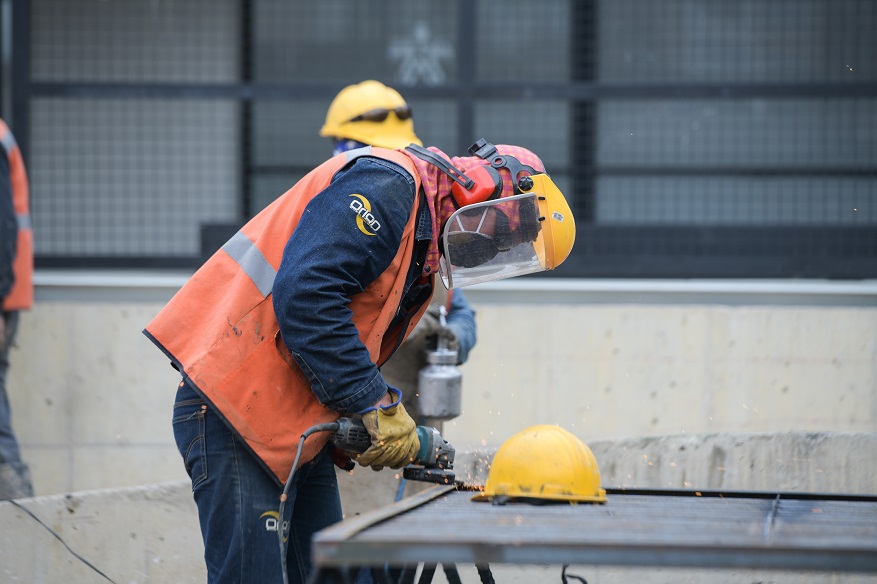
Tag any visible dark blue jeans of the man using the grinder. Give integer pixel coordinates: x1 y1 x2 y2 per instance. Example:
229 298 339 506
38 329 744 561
173 382 341 584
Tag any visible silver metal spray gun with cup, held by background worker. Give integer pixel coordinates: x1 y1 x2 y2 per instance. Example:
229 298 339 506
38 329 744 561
418 306 463 420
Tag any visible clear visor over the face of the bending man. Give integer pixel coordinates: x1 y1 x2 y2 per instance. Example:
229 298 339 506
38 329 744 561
439 192 550 289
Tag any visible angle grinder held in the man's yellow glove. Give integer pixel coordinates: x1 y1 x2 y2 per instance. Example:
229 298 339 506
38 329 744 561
329 418 455 484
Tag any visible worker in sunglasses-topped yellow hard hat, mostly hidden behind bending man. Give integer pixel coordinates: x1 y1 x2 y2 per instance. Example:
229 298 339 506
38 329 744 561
320 79 477 426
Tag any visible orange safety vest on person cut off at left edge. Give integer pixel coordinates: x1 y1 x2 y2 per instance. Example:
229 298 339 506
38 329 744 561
0 120 33 311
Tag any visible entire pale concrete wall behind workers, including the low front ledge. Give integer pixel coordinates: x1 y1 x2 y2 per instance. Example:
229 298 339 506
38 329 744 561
0 273 877 584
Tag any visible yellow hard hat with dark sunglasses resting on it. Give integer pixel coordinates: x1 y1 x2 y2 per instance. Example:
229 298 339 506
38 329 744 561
320 80 423 149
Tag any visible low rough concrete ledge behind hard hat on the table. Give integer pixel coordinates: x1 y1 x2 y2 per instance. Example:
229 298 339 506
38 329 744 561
455 432 877 495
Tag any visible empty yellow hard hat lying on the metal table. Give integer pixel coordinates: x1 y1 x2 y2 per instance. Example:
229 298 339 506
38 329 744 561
472 424 606 503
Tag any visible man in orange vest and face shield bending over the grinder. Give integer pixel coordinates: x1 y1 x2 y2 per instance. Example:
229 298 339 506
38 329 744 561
144 129 575 584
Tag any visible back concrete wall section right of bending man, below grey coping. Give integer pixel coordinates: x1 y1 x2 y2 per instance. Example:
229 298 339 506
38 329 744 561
446 304 877 452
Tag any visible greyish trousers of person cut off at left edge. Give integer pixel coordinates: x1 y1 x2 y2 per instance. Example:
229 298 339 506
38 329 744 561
0 310 33 500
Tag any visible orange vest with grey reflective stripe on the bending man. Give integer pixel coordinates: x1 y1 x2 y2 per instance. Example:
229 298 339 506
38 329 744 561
144 148 432 484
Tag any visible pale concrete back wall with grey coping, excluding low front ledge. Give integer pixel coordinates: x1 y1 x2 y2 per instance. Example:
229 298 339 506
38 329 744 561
3 272 877 495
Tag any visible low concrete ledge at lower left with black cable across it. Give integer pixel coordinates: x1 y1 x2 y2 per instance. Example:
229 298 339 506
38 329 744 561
0 480 200 584
